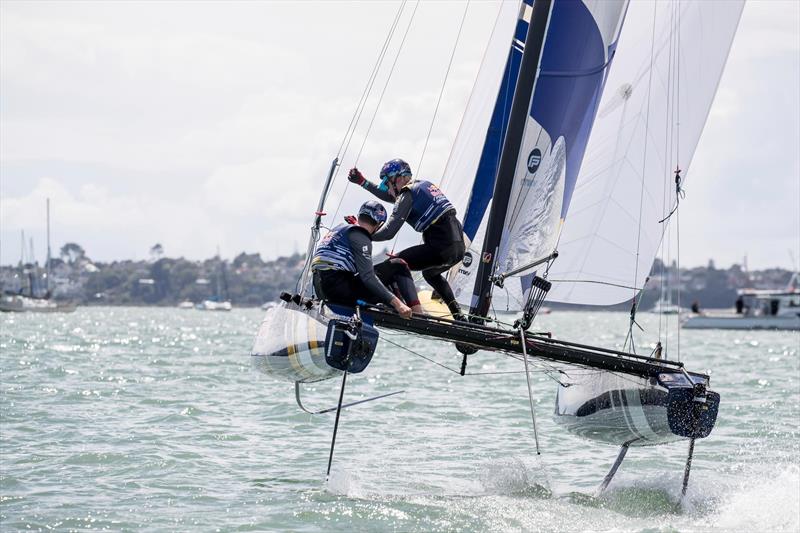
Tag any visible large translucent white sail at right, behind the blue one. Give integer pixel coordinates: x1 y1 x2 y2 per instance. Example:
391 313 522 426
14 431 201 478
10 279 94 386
548 0 744 305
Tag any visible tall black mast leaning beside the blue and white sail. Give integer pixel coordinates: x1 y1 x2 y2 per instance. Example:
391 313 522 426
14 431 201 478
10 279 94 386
470 0 551 316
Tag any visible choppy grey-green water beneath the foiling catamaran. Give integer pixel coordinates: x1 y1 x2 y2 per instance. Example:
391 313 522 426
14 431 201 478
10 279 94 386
0 308 800 531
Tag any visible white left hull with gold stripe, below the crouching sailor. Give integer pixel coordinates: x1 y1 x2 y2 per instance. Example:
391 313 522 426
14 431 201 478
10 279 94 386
250 304 341 383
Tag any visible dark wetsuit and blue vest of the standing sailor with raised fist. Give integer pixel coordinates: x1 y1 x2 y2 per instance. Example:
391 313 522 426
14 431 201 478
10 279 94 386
363 181 466 305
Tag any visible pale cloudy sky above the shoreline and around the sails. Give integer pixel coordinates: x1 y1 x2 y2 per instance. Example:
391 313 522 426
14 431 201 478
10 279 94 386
0 0 800 268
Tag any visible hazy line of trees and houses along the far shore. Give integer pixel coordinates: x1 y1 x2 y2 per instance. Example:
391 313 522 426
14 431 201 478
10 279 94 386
0 243 792 310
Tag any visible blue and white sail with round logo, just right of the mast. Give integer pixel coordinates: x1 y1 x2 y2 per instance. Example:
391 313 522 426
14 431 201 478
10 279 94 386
493 0 628 308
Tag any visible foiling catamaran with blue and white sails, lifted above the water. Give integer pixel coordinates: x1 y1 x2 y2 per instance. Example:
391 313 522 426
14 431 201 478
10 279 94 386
251 0 743 493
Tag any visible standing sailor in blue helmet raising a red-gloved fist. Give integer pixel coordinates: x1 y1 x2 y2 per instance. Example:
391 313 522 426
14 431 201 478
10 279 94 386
347 159 465 320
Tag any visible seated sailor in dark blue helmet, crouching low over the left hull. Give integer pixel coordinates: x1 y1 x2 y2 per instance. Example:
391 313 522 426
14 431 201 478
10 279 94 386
311 201 419 318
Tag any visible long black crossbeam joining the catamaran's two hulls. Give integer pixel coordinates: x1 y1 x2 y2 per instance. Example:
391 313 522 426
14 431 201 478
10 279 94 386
361 306 696 379
